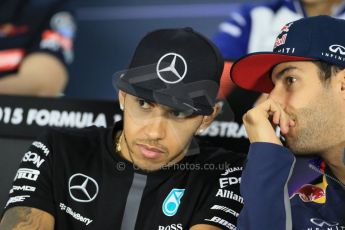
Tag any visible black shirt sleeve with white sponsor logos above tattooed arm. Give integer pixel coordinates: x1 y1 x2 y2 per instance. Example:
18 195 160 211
3 130 55 216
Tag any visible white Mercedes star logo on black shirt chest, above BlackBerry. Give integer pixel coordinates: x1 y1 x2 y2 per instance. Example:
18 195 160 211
68 173 98 203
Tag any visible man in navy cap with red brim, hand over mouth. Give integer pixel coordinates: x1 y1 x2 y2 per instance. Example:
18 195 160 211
231 16 345 230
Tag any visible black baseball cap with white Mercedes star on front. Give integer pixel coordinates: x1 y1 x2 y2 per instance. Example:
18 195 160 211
115 28 224 115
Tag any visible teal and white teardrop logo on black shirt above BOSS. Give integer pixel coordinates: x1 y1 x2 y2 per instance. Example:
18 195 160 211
162 188 185 216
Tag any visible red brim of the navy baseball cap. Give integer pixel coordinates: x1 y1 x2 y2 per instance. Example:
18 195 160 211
230 52 317 93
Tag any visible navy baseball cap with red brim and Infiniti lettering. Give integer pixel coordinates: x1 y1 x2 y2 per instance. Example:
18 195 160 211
230 15 345 93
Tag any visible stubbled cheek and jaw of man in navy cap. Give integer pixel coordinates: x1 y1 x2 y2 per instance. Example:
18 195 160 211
286 90 344 155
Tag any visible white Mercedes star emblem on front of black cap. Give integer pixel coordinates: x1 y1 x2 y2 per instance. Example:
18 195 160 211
156 53 187 84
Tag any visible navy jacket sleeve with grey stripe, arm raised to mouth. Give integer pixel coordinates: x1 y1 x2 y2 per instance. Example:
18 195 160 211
237 142 295 230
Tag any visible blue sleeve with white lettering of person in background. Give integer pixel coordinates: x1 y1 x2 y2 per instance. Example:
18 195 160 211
212 5 251 61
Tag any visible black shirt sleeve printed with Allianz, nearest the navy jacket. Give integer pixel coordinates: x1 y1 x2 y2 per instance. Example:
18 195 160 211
191 156 243 230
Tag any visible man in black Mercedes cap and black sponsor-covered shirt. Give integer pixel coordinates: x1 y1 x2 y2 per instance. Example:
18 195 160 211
0 28 243 230
